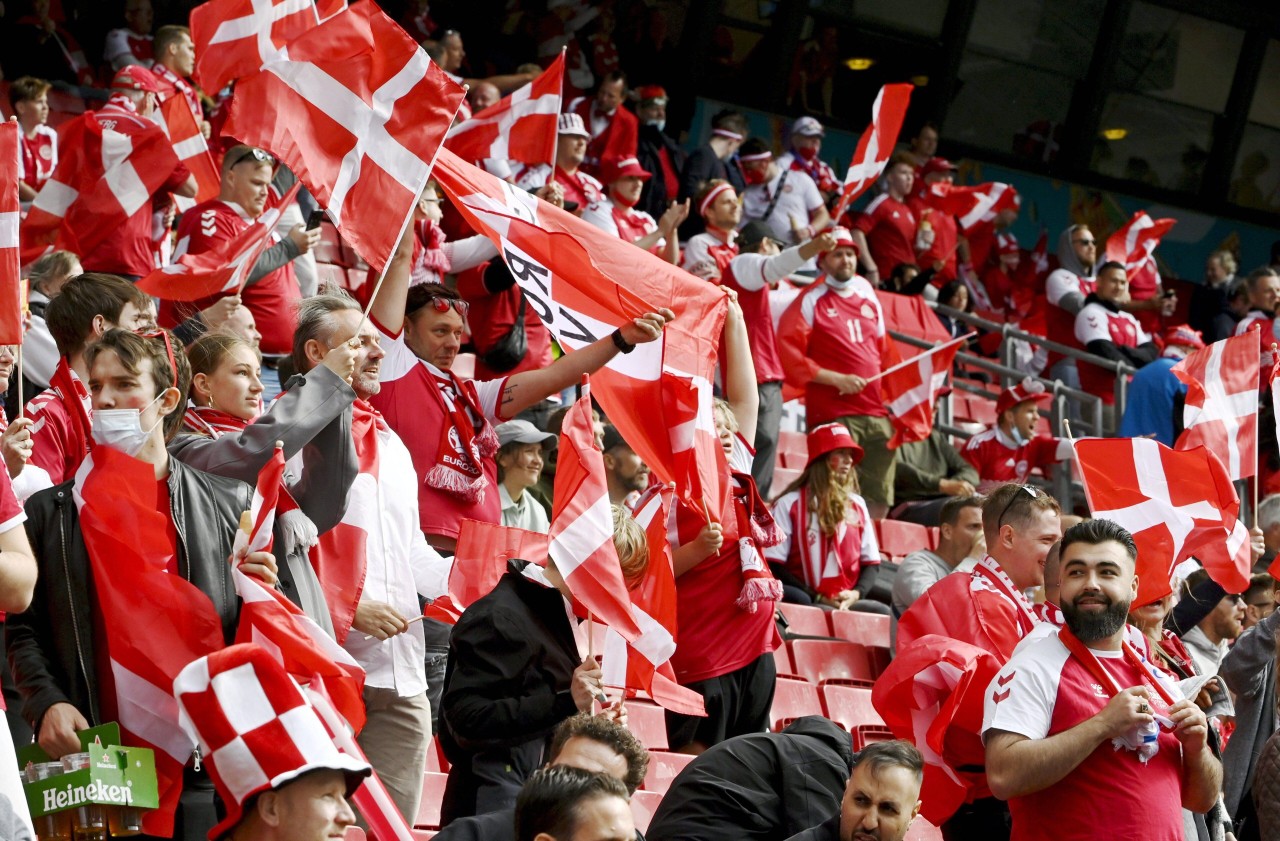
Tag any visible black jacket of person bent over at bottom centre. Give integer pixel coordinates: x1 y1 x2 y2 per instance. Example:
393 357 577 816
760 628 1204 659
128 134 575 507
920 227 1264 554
645 716 854 841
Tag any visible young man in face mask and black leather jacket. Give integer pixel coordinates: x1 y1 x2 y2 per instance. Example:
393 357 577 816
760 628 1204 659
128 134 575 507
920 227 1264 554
6 329 276 837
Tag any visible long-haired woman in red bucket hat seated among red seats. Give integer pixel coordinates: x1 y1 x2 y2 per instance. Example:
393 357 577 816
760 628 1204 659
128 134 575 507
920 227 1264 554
764 422 890 616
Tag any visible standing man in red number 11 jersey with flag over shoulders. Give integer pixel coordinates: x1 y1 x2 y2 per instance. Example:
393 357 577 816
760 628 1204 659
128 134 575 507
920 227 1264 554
778 228 896 520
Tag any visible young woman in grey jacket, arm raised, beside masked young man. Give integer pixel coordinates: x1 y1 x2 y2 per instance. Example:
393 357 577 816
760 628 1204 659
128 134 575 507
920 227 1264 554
169 330 356 629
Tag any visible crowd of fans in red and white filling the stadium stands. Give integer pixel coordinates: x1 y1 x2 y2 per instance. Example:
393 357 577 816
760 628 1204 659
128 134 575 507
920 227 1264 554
0 0 1280 841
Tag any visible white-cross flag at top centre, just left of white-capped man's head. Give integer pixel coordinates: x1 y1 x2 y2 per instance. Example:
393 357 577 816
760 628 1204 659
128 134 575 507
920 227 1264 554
444 51 564 166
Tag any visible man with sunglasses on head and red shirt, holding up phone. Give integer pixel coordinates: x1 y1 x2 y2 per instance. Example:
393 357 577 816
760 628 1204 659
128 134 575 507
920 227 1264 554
160 146 320 356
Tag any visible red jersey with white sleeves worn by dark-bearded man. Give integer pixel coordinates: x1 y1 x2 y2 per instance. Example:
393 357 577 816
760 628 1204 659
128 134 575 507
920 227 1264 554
982 634 1183 841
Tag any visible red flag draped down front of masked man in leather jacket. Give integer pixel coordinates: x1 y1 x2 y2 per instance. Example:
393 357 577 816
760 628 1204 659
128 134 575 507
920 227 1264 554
73 445 224 837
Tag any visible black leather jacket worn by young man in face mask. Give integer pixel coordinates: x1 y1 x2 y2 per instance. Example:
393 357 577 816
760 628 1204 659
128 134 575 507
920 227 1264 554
5 458 252 732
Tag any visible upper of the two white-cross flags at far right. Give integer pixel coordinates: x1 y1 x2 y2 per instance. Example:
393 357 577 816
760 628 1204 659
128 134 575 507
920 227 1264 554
1172 332 1258 478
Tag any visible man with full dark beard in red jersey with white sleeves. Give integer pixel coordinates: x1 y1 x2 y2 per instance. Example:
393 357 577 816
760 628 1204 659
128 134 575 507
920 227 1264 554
983 520 1222 841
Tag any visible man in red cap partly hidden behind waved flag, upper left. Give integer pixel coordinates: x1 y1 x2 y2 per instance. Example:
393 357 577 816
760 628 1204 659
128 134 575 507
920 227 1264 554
81 64 196 280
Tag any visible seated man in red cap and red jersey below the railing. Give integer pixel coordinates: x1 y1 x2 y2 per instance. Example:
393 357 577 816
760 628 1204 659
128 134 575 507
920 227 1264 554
960 378 1071 493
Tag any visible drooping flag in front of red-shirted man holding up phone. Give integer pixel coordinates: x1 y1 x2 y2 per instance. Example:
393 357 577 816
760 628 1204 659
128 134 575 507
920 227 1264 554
138 183 301 301
